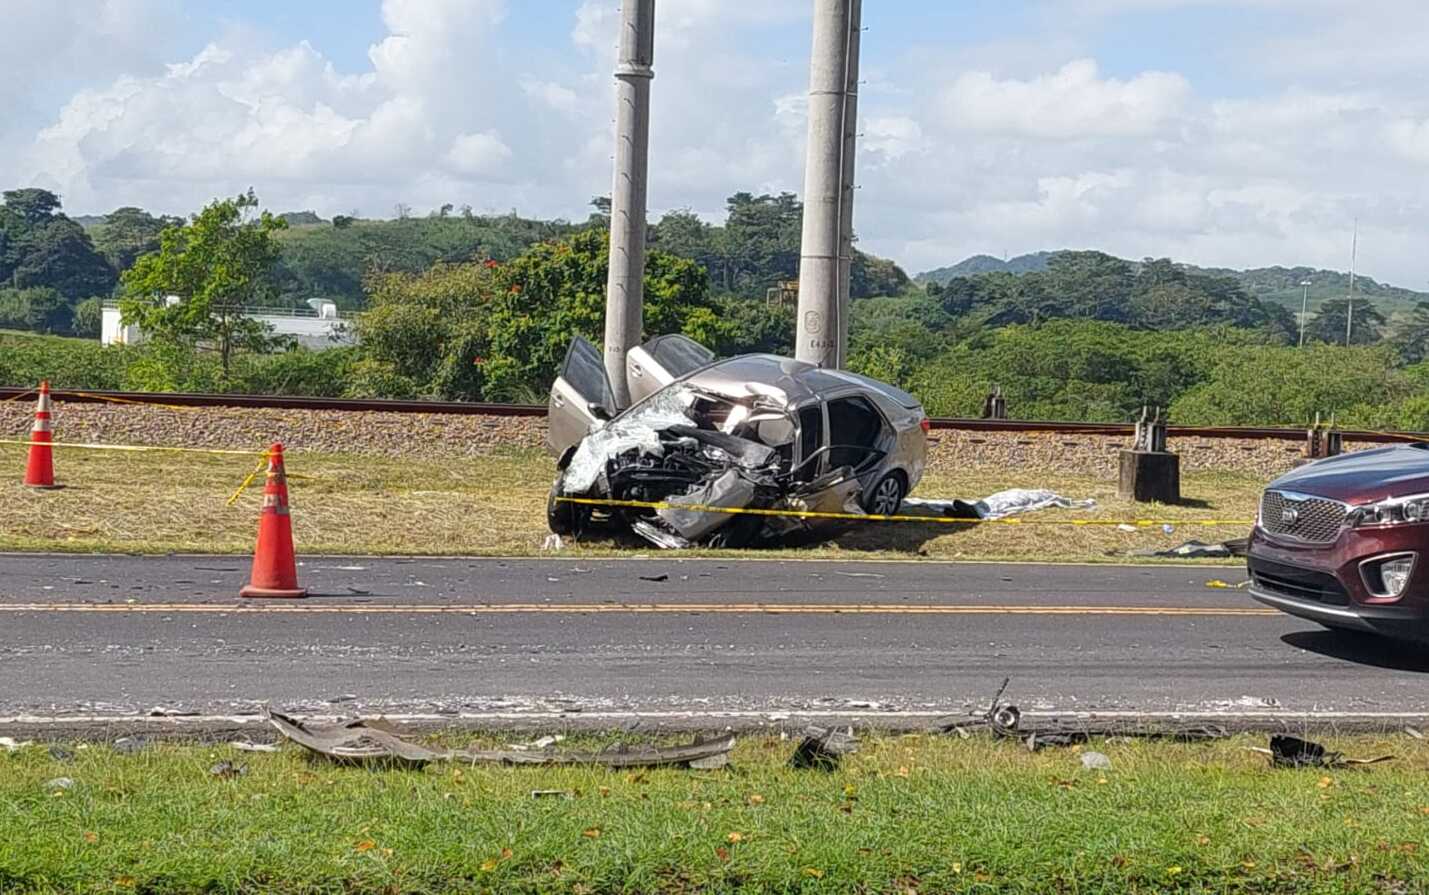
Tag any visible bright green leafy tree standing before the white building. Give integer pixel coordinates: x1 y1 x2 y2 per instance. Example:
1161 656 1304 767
120 190 287 380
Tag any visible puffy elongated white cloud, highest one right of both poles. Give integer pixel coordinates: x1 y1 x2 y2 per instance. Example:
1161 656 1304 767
942 59 1190 139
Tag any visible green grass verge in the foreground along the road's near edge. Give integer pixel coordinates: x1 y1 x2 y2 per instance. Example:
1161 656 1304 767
0 736 1429 894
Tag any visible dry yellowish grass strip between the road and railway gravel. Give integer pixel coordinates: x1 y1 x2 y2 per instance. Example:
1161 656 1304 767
0 446 1262 562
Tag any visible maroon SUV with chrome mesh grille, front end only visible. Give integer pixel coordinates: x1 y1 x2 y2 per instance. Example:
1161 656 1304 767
1248 445 1429 639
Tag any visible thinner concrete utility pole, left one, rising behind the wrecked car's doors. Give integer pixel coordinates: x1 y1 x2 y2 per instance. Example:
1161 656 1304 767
606 0 654 407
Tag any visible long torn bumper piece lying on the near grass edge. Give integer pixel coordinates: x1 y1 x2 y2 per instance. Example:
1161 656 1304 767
266 711 735 771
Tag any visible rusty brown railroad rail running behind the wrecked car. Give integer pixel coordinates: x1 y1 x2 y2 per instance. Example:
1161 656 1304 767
0 386 1429 445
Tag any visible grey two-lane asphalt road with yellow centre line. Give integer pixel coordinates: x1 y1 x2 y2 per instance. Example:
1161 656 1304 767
0 555 1429 728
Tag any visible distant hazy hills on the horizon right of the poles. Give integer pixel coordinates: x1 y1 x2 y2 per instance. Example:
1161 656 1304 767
916 252 1429 316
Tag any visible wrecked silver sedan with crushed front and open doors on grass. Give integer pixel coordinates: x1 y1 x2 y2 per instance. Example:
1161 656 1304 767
546 336 927 548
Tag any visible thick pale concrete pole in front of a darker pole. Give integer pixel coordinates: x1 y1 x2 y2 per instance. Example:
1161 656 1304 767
795 0 850 367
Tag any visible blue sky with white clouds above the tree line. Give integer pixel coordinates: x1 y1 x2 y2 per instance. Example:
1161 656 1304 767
0 0 1429 287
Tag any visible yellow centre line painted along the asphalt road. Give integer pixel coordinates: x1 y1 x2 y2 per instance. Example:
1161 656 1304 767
0 602 1280 616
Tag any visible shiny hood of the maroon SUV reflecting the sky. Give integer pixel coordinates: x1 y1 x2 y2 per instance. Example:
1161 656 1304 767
1270 443 1429 503
